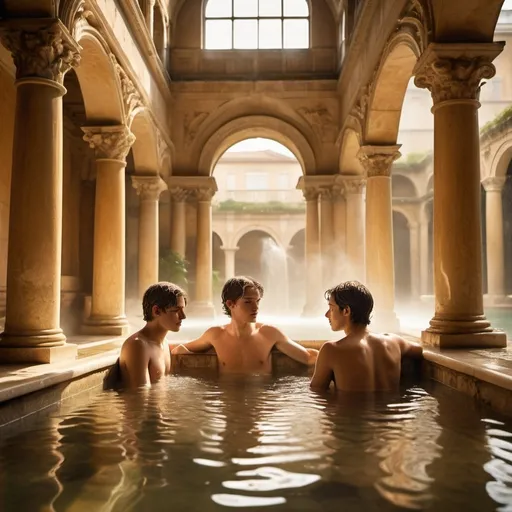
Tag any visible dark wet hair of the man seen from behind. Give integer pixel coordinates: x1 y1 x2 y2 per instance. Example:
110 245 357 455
325 281 373 325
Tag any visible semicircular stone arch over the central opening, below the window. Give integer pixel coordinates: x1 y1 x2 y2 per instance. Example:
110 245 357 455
198 115 316 176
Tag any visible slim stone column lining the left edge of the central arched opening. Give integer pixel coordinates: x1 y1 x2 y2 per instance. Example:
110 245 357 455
191 184 217 318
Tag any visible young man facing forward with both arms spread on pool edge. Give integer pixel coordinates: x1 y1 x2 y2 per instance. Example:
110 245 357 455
172 276 318 374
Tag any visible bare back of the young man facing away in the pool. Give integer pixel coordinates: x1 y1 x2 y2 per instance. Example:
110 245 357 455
311 333 414 391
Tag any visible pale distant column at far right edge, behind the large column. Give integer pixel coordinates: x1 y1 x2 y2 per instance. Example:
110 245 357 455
482 176 506 304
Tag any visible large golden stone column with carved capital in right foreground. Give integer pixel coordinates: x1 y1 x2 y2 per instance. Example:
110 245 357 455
414 43 506 347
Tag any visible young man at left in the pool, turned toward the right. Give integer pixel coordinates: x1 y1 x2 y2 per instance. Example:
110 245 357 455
119 282 187 389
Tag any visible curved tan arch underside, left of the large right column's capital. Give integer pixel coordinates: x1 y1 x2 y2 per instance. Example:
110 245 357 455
364 31 421 145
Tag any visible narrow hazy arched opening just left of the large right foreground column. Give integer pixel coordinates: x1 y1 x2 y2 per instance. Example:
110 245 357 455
393 211 412 303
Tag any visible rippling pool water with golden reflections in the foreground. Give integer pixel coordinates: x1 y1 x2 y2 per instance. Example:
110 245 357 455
0 376 512 512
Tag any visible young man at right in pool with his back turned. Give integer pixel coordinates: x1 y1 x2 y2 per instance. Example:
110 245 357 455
311 281 423 391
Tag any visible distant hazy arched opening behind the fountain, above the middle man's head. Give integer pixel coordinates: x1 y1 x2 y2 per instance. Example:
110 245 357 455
235 231 288 315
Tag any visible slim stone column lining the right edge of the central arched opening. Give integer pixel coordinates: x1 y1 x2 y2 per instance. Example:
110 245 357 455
302 187 323 316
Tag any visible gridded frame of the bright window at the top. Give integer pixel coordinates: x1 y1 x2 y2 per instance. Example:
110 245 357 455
202 0 311 52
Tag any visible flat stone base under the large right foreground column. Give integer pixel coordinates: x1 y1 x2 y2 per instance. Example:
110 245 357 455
421 329 507 348
